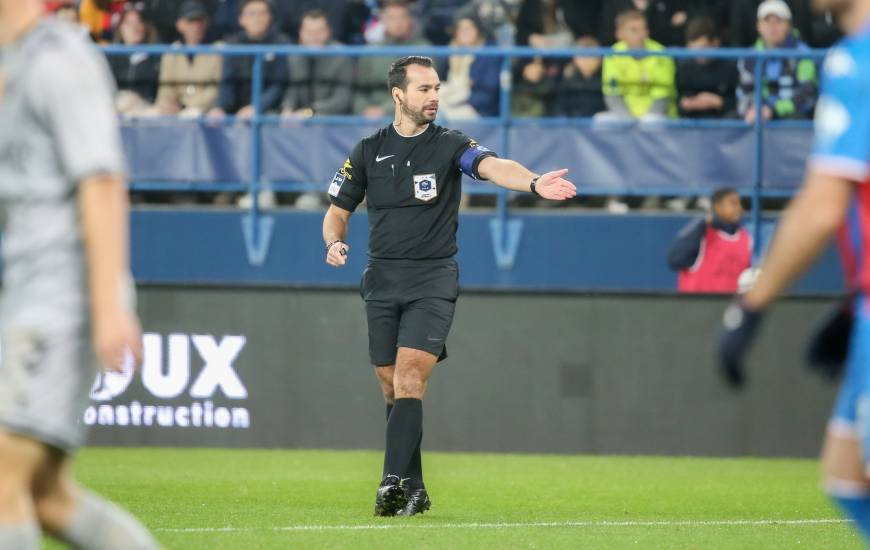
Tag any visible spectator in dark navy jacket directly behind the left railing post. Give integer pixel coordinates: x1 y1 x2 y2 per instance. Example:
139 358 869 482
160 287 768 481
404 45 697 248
208 0 289 118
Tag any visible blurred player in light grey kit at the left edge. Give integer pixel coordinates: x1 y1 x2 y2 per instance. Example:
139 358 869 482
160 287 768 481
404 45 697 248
0 0 157 550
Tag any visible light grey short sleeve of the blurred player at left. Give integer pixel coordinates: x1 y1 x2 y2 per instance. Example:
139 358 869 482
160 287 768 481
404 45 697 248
26 49 125 185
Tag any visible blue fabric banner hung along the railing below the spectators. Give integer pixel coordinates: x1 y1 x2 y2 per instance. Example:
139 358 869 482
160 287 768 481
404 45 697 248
123 121 812 196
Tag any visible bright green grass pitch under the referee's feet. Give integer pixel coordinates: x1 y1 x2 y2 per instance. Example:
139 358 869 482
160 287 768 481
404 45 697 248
49 448 862 550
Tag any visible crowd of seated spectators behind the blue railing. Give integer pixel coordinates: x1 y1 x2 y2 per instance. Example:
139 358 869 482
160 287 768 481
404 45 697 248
49 0 840 209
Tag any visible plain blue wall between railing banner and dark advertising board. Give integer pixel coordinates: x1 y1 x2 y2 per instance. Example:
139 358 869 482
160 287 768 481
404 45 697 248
131 208 843 294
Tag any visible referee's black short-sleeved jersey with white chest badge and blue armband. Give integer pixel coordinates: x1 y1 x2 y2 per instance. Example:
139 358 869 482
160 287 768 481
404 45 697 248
329 124 495 260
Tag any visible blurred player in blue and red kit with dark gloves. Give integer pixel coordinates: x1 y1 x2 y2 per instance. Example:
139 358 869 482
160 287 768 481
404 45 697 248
718 0 870 540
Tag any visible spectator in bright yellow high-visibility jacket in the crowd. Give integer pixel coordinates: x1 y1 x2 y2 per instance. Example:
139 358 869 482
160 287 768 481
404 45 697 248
601 10 677 118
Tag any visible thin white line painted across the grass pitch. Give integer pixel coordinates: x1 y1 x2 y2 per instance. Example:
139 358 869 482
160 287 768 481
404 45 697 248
154 519 849 533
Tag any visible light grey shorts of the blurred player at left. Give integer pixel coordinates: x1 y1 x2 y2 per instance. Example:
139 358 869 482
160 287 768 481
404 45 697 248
0 327 96 453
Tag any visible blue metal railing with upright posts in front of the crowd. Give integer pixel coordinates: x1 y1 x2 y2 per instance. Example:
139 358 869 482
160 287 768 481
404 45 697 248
103 44 827 256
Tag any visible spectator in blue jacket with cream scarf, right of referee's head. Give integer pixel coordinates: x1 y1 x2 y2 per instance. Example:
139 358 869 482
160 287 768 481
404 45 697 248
439 16 501 119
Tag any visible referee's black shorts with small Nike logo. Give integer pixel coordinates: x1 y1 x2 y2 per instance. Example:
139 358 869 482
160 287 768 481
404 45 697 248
360 258 459 366
